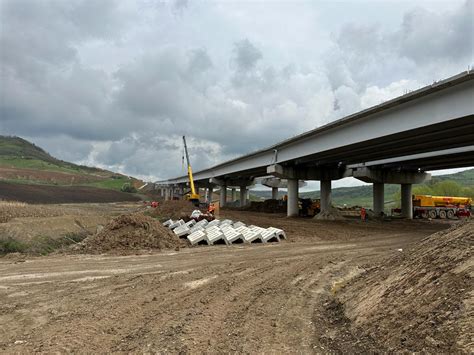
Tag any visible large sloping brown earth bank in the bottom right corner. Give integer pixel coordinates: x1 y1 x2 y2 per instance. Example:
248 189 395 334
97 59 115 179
339 221 474 353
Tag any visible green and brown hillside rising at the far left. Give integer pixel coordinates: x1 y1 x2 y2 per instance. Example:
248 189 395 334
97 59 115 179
0 136 142 191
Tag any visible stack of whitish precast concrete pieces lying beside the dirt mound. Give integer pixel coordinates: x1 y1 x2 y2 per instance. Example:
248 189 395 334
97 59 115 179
163 219 286 245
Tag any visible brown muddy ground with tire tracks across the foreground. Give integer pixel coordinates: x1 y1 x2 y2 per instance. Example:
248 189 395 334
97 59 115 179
0 206 458 353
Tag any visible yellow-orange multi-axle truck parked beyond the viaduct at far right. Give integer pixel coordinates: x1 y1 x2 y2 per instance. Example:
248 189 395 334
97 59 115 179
413 195 472 219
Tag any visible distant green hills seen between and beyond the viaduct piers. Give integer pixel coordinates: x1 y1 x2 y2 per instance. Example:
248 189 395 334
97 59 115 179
251 169 474 208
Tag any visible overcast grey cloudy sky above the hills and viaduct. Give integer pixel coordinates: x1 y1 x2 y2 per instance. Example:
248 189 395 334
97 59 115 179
0 0 474 189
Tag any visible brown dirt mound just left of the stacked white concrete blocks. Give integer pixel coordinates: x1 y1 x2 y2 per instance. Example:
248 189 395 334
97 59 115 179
75 213 186 254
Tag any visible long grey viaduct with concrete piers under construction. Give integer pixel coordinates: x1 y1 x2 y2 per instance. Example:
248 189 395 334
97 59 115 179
156 71 474 218
